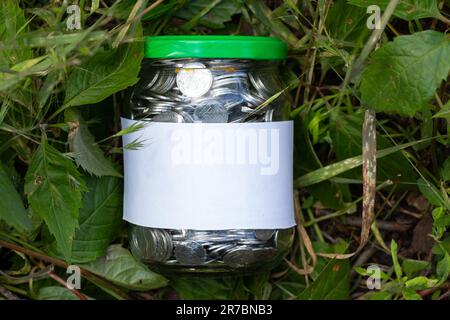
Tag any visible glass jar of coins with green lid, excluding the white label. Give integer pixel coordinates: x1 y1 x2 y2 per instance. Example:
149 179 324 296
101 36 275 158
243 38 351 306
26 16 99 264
124 36 294 274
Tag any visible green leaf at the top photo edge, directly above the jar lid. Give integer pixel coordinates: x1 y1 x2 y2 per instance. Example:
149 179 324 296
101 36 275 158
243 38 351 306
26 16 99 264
175 0 242 29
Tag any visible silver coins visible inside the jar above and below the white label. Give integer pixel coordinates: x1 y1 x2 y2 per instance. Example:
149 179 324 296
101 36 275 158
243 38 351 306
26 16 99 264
127 59 292 269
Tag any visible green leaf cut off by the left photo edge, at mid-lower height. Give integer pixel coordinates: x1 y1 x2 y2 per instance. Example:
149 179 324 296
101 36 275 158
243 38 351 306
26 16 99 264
0 163 32 231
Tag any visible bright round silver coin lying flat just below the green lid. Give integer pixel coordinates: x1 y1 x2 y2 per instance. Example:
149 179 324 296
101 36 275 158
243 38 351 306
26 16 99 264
176 62 213 98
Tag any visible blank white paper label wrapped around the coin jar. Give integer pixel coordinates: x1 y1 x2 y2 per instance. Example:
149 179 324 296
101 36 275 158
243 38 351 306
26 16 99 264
122 118 295 230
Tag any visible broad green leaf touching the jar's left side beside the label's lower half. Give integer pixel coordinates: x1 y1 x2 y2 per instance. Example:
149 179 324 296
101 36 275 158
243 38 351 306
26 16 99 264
51 177 122 263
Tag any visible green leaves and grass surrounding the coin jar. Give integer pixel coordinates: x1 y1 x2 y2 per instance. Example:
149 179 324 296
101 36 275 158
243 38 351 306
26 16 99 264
0 0 450 299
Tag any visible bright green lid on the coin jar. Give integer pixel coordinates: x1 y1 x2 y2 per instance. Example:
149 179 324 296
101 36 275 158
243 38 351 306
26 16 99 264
145 35 287 60
